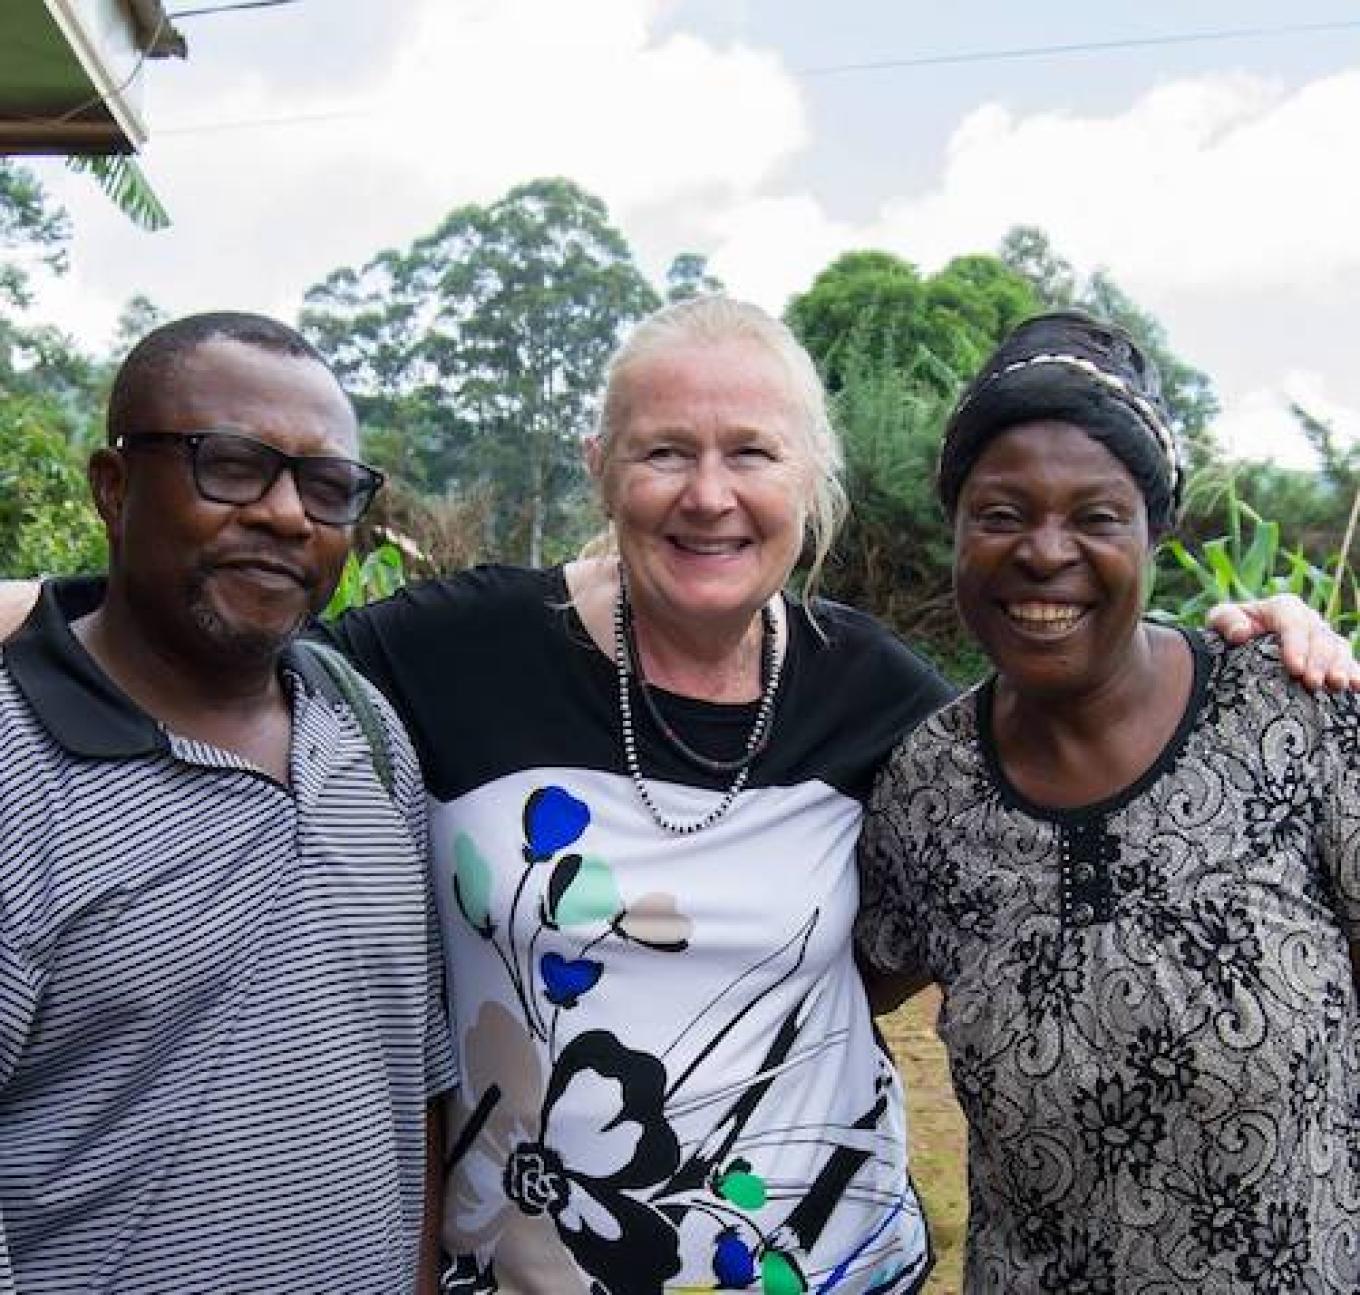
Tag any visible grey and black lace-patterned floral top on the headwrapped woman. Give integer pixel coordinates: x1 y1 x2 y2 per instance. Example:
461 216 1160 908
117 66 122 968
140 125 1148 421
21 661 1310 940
857 635 1360 1295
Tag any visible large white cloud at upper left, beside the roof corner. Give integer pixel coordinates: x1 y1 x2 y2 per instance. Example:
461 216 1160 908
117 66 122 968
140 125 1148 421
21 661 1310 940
23 0 806 343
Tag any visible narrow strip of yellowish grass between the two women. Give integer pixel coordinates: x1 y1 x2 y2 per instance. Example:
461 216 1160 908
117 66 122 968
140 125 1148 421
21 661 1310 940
879 989 968 1295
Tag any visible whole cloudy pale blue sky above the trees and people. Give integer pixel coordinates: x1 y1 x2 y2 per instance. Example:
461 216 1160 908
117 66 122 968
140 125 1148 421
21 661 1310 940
18 0 1360 465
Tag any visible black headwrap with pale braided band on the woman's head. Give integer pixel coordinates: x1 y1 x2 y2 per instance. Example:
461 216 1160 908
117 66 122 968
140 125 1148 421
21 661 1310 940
937 310 1185 540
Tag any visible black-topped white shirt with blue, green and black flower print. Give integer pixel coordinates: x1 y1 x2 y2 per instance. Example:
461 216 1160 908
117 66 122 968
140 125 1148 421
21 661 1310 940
333 567 951 1295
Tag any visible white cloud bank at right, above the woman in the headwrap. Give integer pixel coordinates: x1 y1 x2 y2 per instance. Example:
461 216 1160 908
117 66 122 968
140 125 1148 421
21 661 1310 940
696 72 1360 473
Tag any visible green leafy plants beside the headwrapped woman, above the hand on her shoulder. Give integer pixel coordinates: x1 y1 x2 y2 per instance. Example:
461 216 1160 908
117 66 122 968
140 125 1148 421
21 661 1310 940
1153 490 1360 645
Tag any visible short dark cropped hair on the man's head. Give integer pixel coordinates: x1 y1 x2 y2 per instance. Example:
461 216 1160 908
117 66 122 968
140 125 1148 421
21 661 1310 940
107 310 348 445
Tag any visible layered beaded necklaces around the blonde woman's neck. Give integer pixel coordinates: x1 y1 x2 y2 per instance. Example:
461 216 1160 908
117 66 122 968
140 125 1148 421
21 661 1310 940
613 570 783 835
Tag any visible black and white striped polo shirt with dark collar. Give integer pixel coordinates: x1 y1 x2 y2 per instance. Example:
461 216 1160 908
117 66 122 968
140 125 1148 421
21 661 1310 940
0 581 454 1295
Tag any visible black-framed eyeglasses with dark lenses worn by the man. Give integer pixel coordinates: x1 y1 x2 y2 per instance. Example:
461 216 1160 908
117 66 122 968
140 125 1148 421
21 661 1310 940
117 428 382 526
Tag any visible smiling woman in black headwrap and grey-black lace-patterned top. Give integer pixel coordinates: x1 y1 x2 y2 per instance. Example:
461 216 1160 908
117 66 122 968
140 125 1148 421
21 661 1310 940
857 313 1360 1295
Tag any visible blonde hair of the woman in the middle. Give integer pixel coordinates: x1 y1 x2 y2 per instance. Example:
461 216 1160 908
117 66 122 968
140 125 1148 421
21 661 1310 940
581 297 846 599
